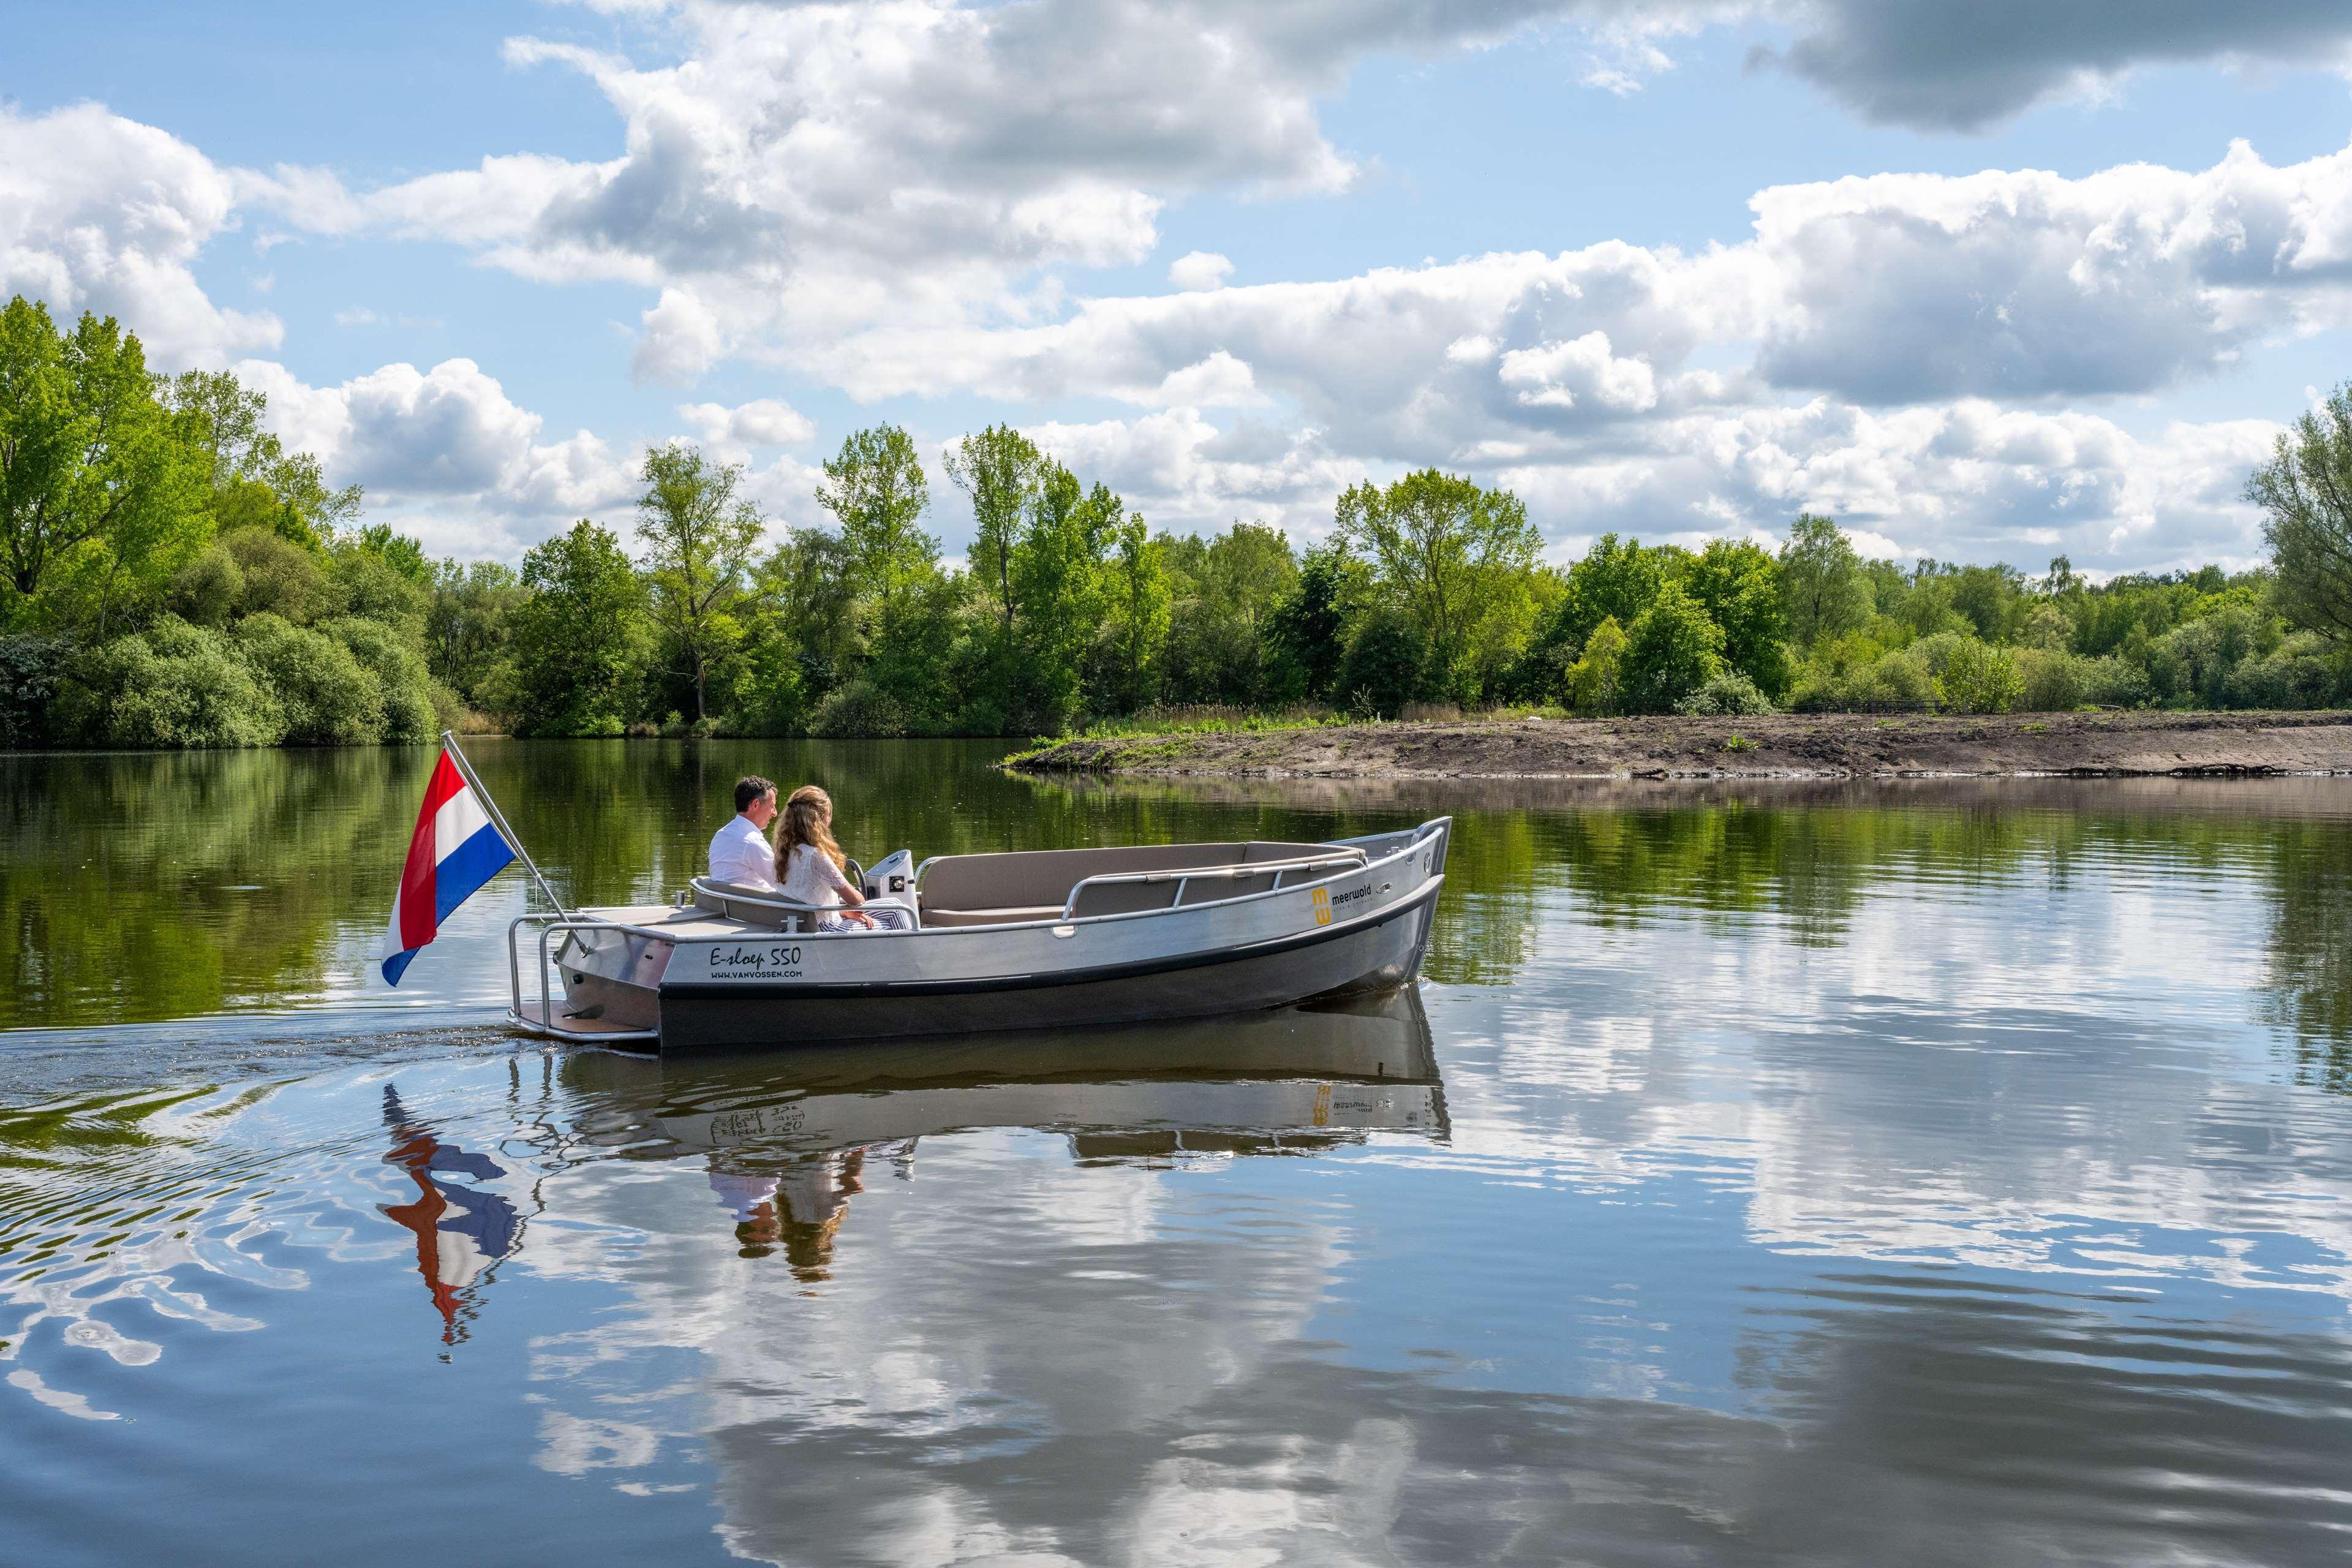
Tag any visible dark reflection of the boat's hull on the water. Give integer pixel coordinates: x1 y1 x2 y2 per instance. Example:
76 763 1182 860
565 990 1447 1170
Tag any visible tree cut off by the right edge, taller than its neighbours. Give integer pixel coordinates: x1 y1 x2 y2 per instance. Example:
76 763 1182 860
2246 381 2352 646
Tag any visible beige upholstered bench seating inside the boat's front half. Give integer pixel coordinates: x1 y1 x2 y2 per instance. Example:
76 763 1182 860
919 839 1364 926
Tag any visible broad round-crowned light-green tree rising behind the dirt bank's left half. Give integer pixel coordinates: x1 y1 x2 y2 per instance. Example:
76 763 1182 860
1338 468 1543 696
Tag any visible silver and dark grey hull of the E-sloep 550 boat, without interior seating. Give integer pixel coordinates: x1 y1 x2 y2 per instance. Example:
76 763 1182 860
527 818 1451 1051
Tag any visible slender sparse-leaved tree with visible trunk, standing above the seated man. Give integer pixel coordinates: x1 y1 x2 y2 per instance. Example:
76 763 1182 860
638 442 767 722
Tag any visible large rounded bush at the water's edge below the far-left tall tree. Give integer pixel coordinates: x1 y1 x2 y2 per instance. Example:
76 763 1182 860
59 616 285 748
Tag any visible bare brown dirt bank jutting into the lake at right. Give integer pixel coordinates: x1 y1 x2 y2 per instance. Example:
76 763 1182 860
1014 712 2352 778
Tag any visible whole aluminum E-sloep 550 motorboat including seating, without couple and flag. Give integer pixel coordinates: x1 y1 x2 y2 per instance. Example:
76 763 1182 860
506 818 1453 1051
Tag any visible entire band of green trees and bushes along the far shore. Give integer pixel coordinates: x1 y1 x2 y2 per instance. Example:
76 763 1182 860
0 298 2352 745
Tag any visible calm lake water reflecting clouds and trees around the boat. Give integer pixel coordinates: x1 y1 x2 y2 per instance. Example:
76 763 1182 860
0 743 2352 1566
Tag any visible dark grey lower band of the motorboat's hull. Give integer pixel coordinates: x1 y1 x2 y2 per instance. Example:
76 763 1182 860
658 884 1437 1051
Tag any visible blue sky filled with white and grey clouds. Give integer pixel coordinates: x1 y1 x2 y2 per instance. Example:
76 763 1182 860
0 0 2352 571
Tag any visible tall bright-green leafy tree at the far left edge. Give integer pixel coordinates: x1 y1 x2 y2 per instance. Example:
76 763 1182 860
0 294 207 639
